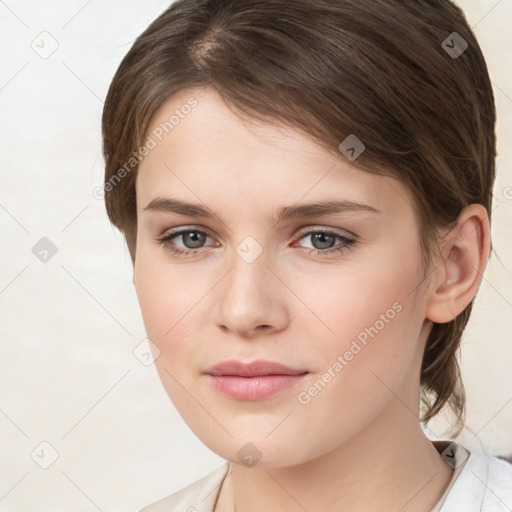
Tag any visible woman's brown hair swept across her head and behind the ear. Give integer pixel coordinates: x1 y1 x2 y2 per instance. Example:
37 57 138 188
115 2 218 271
102 0 496 432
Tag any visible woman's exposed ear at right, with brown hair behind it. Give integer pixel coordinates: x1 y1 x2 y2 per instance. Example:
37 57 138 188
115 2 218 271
426 204 490 324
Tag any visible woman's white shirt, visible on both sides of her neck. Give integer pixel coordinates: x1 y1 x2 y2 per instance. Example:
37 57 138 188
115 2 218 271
140 441 512 512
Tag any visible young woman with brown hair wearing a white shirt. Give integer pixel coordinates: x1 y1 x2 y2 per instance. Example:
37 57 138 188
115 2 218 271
103 0 512 512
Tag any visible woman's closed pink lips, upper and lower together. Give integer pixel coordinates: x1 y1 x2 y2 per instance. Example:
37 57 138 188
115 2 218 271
204 361 308 400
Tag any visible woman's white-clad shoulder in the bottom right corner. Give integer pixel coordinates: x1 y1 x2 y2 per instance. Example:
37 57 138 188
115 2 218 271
441 446 512 512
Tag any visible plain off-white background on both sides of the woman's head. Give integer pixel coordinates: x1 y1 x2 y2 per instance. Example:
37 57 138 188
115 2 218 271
0 0 512 512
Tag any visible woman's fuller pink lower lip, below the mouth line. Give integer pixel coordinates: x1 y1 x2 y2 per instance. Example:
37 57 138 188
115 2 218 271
208 373 307 400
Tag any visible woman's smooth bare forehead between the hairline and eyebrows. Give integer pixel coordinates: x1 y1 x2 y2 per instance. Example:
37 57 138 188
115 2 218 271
136 88 412 220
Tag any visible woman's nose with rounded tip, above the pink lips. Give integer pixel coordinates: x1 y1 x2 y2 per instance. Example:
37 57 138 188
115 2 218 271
216 251 289 339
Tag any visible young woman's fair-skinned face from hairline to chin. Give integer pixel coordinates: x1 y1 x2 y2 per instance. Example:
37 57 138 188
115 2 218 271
134 89 432 467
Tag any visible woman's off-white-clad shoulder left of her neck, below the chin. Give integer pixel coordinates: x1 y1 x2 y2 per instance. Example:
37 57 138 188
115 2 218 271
140 461 229 512
